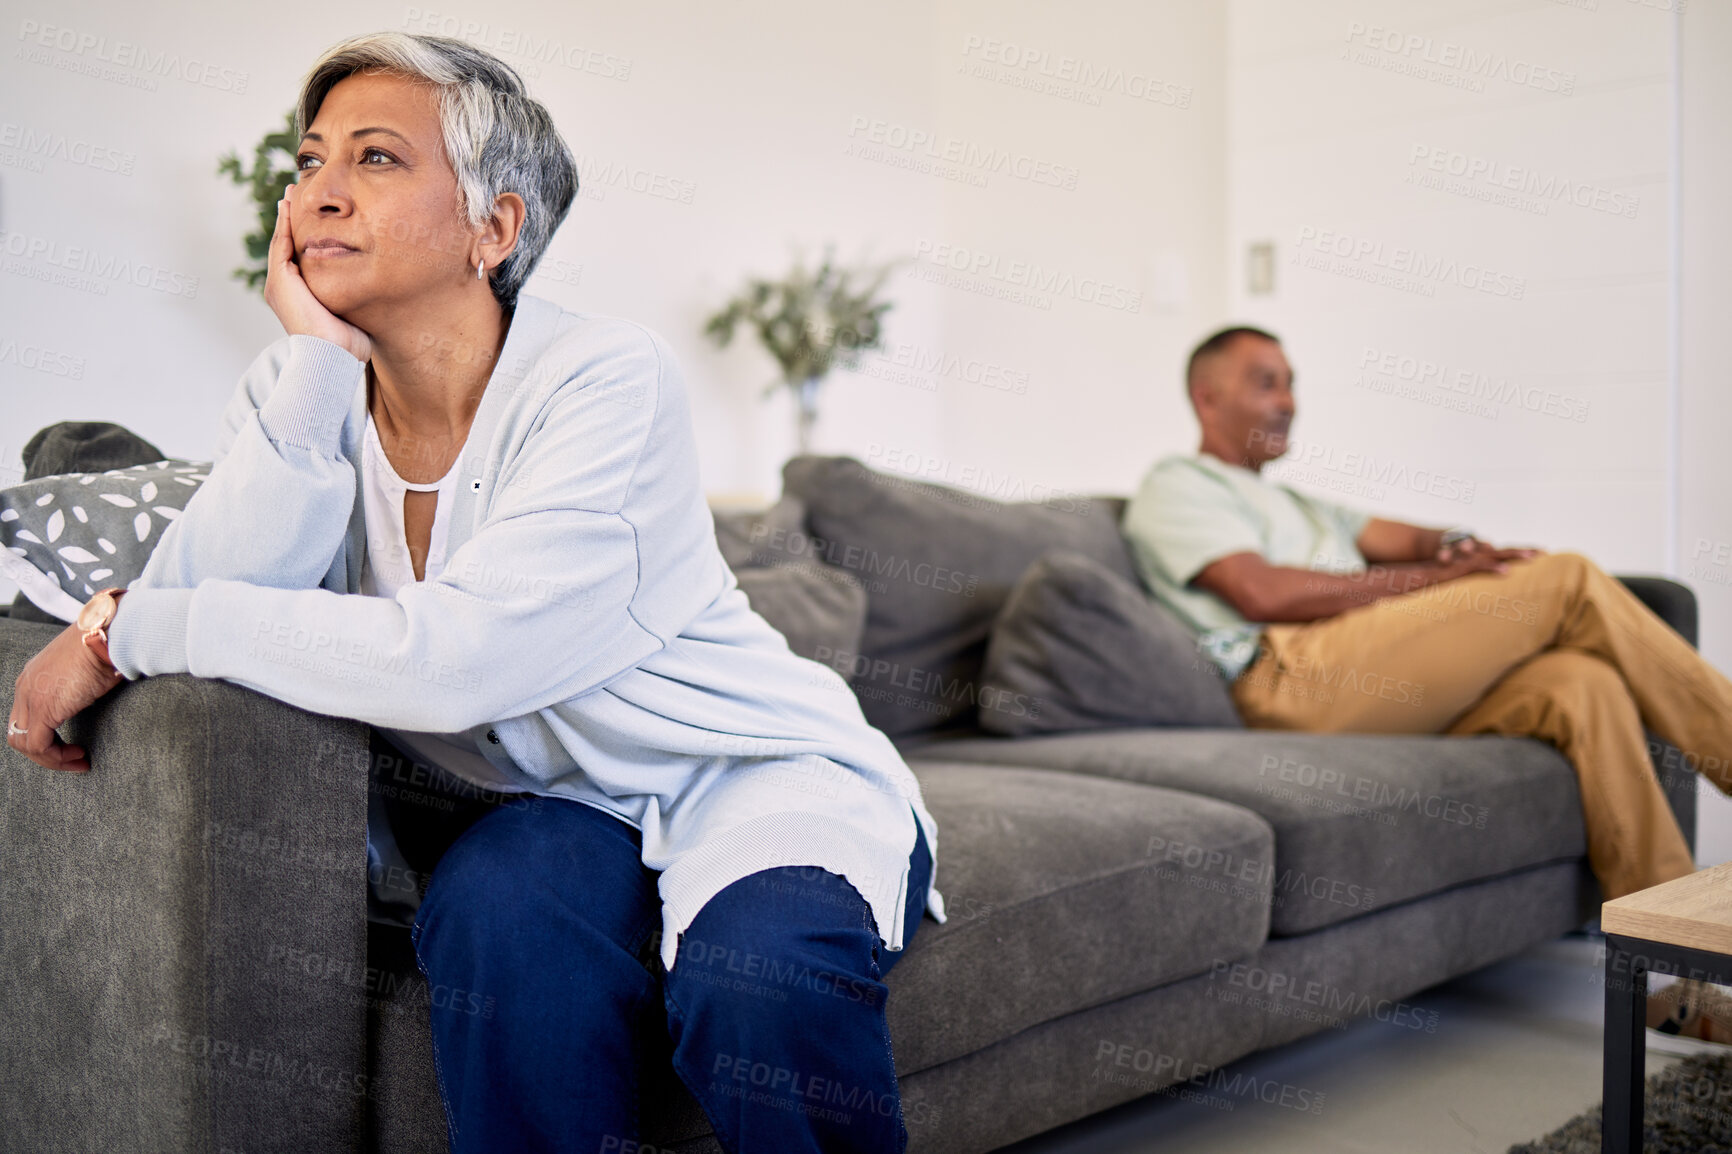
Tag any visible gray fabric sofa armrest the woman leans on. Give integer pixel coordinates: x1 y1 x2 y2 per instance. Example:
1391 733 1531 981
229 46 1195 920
0 619 369 1154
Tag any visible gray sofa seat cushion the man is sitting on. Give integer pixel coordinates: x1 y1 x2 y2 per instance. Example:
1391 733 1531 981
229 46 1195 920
902 729 1587 936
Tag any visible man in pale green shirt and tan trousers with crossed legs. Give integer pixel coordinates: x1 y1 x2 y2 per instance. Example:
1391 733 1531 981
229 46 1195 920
1122 327 1732 1040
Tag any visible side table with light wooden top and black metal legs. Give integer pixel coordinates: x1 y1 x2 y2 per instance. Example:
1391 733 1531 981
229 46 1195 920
1600 861 1732 1154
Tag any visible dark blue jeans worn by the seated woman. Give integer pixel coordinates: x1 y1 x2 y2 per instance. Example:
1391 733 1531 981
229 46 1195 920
410 797 932 1154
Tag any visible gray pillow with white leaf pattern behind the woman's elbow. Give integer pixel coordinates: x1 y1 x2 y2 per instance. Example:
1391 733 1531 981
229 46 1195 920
0 457 211 622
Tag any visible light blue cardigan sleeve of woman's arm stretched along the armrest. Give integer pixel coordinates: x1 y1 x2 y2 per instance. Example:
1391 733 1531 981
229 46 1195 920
109 509 663 733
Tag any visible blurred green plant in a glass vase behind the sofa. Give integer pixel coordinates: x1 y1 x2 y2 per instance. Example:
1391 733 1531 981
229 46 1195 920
703 246 901 452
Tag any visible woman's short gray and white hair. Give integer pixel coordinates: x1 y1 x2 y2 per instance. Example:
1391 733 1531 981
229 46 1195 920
294 31 577 312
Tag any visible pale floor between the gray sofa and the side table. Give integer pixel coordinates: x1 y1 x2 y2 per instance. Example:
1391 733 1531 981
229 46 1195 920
1003 936 1704 1154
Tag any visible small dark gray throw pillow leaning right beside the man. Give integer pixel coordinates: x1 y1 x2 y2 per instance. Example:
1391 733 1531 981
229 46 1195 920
980 549 1244 736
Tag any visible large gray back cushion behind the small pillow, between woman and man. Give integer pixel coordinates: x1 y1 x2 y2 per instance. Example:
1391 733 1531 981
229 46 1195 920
782 456 1134 736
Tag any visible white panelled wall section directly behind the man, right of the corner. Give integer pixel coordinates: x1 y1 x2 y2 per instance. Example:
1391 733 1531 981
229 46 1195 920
1226 0 1673 570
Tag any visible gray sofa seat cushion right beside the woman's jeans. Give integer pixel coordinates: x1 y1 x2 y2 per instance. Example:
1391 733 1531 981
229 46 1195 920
885 761 1273 1074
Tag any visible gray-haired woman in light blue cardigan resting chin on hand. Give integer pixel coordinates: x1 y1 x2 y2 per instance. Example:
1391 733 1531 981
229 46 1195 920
9 33 942 1154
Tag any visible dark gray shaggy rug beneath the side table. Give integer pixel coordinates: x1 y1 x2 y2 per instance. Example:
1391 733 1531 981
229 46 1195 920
1509 1054 1732 1154
